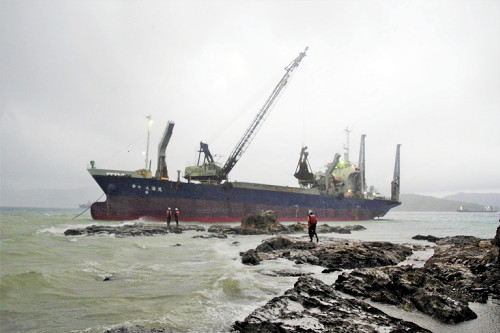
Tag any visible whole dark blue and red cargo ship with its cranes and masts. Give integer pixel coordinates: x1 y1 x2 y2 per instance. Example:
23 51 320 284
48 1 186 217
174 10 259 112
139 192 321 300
88 48 401 222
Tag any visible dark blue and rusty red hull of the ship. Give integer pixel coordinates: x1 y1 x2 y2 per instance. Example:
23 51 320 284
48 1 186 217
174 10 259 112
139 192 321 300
91 176 401 223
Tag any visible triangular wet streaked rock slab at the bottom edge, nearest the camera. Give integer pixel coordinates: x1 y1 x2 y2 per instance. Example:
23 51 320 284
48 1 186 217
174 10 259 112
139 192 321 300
233 277 429 333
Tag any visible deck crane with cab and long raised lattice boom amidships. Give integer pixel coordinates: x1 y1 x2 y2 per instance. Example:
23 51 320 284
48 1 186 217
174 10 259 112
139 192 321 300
184 47 308 184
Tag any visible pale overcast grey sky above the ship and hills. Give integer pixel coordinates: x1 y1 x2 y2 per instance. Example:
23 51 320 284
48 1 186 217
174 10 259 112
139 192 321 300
0 0 500 200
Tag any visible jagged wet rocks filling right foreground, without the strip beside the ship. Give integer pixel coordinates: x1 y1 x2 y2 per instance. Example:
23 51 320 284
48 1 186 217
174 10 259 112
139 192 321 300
233 227 500 332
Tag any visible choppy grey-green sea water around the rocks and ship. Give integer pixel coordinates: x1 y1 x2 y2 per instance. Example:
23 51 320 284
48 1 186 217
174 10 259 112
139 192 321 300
0 208 500 333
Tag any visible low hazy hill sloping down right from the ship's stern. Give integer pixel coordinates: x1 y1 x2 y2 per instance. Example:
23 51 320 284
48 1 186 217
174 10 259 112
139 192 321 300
393 194 492 212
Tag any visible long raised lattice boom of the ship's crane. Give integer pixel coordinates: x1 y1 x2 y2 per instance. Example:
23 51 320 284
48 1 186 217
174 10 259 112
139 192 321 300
219 47 308 182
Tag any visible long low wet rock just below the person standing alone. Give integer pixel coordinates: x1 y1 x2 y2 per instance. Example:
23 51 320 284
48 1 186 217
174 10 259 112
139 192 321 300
240 236 412 269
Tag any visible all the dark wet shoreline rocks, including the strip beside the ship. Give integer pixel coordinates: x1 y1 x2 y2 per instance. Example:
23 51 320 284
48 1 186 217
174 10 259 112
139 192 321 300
65 212 500 333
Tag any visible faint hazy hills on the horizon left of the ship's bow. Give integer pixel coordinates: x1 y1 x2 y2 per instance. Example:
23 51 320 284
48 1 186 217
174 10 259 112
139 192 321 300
0 186 103 209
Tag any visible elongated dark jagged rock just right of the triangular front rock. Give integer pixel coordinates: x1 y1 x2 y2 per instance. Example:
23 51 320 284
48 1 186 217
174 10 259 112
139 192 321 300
335 266 477 323
